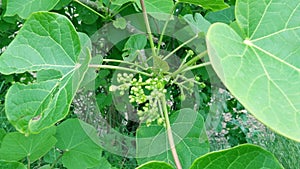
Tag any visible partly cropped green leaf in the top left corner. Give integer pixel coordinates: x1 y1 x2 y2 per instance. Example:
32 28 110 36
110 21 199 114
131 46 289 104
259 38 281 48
4 0 59 19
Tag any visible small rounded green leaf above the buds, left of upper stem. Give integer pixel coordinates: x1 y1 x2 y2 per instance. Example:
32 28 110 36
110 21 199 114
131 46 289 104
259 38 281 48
122 34 147 62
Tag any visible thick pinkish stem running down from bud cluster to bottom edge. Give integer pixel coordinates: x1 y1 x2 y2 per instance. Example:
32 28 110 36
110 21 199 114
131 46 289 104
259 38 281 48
160 96 182 169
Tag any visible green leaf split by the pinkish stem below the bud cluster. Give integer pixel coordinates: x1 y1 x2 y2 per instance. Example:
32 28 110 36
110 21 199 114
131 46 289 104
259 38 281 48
137 109 209 168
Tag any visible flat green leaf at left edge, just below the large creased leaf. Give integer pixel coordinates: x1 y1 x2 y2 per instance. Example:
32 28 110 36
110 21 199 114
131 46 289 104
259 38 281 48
0 127 56 163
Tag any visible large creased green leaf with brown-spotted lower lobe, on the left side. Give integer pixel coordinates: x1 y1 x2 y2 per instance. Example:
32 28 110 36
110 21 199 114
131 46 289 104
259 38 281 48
0 12 90 134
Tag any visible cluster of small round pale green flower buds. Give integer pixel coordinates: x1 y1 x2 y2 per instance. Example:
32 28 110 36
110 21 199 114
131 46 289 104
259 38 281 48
110 73 167 125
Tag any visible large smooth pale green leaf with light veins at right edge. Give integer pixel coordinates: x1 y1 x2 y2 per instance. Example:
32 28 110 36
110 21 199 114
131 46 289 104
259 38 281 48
207 0 300 141
